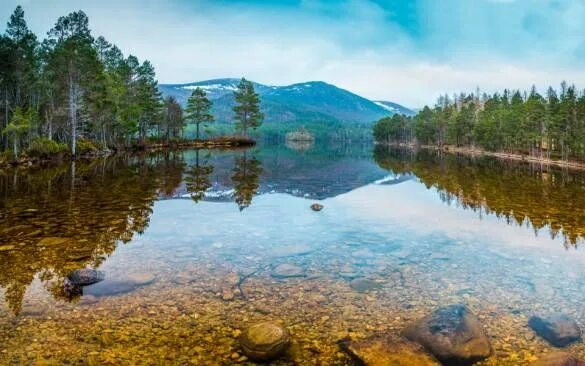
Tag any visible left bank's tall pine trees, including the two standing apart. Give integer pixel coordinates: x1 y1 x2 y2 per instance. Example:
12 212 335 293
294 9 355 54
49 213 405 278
0 6 263 158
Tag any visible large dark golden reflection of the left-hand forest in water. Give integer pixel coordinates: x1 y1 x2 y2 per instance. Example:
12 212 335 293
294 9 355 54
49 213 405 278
0 156 182 313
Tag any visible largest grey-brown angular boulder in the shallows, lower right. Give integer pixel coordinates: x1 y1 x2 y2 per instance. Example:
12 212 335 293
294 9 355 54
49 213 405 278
404 304 492 365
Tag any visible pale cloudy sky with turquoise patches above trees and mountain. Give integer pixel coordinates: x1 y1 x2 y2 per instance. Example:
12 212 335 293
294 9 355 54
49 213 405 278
0 0 585 108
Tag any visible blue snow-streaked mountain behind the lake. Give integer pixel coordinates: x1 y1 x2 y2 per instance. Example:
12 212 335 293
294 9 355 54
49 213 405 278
159 79 404 125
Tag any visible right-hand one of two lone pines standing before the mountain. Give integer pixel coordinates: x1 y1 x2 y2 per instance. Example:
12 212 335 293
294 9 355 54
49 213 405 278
233 78 264 136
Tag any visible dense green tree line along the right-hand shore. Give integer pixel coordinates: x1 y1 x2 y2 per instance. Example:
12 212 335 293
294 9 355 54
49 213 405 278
374 82 585 160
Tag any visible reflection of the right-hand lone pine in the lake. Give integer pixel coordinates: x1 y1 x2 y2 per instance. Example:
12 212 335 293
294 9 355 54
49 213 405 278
231 151 262 211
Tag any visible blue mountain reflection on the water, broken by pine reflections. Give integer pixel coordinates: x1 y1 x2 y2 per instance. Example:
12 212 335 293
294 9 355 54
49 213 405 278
169 146 387 201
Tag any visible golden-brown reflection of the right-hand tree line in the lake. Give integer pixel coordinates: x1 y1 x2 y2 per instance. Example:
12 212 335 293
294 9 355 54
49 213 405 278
374 147 585 245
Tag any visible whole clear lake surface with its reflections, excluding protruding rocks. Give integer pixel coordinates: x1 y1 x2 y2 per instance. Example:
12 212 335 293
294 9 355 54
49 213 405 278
0 147 585 365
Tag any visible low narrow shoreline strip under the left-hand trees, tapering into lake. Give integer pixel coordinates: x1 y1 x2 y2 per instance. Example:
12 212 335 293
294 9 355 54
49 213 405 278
0 136 256 168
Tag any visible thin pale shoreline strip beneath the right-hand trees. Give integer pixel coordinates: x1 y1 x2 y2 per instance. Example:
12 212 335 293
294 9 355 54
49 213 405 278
384 143 585 171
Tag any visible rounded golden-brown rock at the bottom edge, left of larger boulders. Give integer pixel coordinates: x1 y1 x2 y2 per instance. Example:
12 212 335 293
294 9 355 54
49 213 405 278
240 322 290 362
